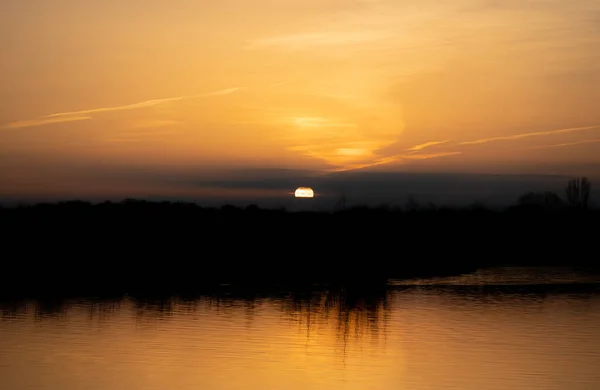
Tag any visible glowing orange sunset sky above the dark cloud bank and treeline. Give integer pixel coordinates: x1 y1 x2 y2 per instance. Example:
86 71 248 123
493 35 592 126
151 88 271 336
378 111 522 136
0 0 600 206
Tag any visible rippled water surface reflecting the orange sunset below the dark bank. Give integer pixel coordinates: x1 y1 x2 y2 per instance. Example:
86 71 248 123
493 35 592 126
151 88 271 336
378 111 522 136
0 269 600 390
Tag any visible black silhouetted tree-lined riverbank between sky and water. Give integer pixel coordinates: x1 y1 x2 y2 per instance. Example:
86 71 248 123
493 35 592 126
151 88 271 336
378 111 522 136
0 201 600 293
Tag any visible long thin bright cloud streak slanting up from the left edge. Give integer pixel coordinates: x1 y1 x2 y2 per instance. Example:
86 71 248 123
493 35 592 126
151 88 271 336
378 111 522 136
0 87 243 129
